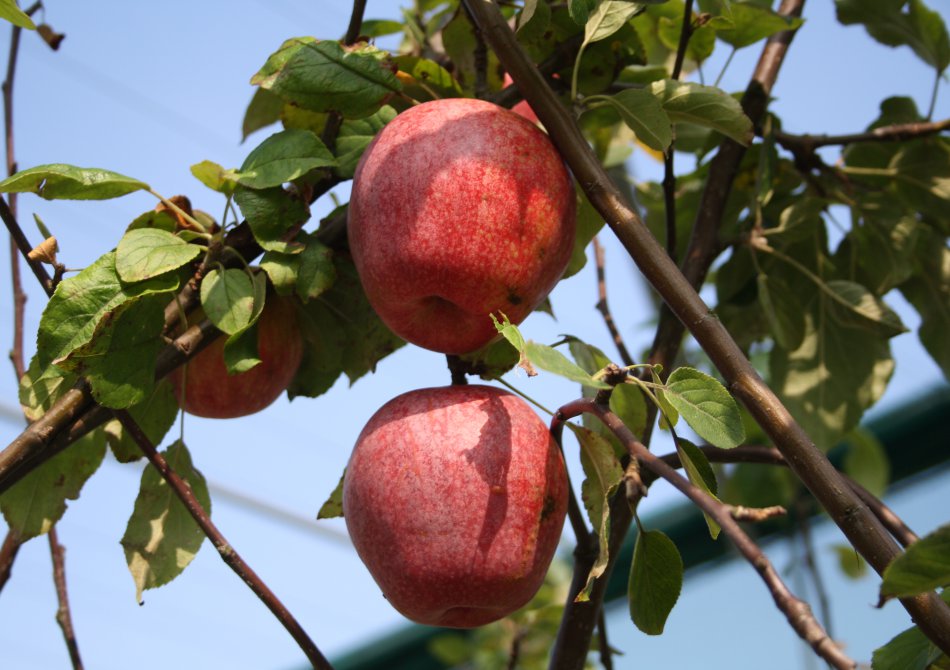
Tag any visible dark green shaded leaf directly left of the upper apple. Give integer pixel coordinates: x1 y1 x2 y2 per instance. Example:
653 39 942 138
234 186 310 253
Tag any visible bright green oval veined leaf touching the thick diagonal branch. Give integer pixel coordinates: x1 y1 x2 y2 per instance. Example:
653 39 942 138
664 367 745 449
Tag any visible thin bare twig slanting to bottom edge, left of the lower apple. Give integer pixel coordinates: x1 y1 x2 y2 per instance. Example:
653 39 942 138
115 410 332 670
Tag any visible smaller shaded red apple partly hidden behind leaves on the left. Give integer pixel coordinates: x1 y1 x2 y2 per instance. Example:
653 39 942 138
169 294 303 419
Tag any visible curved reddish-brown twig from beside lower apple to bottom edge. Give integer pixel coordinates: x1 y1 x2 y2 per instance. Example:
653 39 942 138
558 398 857 670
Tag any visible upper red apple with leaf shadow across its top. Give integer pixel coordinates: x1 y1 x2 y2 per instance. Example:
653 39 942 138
347 98 575 354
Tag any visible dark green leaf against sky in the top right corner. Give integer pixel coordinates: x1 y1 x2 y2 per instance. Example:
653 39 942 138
835 0 950 73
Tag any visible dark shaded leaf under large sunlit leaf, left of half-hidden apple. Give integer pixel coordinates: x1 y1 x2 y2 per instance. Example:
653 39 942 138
58 297 167 409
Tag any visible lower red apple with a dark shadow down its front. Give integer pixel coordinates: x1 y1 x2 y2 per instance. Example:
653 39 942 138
343 385 568 628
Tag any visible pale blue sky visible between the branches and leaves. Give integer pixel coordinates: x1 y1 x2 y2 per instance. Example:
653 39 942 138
0 0 950 670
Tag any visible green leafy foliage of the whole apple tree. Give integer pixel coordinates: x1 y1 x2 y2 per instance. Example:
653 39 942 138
0 0 950 669
